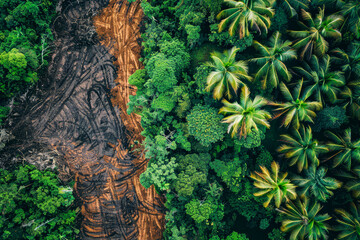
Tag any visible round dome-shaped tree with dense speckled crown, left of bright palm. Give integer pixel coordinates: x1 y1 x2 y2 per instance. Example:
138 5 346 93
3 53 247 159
186 105 226 146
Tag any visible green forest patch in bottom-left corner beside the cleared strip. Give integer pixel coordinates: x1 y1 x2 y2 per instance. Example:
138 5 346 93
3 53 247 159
0 165 79 239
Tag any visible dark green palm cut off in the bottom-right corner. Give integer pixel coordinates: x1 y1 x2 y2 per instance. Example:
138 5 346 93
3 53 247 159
334 203 360 240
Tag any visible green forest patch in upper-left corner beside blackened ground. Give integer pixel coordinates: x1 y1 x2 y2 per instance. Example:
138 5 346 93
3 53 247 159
0 0 56 99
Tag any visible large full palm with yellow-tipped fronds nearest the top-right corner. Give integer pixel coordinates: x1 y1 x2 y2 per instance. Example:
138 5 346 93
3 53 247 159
290 8 343 58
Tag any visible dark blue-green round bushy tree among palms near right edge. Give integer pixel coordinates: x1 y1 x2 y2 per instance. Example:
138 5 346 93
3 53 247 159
313 106 349 132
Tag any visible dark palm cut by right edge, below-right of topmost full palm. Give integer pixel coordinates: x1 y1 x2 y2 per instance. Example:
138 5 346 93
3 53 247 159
332 42 360 79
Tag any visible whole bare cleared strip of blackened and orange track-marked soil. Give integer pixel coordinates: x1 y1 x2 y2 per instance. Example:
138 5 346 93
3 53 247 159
8 0 164 240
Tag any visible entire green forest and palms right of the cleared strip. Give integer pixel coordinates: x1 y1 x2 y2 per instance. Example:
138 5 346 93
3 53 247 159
128 0 360 240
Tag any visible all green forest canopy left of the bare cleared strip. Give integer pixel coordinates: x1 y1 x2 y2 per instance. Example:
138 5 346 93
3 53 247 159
0 0 79 240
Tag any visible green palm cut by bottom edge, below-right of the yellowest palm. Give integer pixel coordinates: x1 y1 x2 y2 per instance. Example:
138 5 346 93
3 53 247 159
278 197 331 240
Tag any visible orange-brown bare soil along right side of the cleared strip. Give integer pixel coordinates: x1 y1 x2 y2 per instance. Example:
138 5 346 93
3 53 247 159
93 0 164 239
